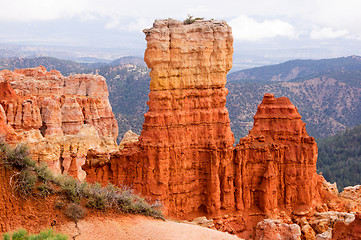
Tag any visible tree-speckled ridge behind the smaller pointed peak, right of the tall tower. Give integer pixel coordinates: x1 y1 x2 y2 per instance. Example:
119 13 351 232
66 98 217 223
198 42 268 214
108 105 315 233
227 56 361 142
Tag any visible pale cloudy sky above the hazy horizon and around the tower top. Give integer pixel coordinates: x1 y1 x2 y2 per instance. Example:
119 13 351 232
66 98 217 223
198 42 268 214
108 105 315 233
0 0 361 68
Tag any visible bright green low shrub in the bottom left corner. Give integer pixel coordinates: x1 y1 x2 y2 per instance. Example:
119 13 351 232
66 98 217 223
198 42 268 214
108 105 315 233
3 229 68 240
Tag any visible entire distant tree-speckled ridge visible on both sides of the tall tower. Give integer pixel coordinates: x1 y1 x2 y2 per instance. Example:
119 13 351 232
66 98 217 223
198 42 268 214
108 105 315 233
0 56 361 142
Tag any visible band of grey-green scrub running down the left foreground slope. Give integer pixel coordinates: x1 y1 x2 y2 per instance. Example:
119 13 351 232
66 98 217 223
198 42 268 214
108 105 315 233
0 140 163 222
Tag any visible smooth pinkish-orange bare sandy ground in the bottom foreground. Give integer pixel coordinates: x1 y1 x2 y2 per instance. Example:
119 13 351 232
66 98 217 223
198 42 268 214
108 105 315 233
56 215 240 240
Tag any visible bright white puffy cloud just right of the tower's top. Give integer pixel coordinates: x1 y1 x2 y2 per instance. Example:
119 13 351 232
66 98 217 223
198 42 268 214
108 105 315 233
229 15 298 41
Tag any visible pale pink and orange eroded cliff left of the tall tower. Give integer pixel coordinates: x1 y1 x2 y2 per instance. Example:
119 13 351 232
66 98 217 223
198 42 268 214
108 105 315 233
0 66 118 179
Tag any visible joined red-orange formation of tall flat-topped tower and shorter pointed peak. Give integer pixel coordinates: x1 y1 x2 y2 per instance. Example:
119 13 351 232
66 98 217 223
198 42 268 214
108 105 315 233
83 19 342 233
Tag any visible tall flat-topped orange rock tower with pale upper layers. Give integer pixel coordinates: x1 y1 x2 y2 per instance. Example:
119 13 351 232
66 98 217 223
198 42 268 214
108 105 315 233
87 19 234 216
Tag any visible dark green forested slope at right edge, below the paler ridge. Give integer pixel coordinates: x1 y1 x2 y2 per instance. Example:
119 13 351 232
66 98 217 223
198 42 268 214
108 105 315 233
317 125 361 190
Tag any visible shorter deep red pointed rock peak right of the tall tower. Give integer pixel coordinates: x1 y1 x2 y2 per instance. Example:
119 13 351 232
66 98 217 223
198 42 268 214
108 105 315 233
235 94 324 215
